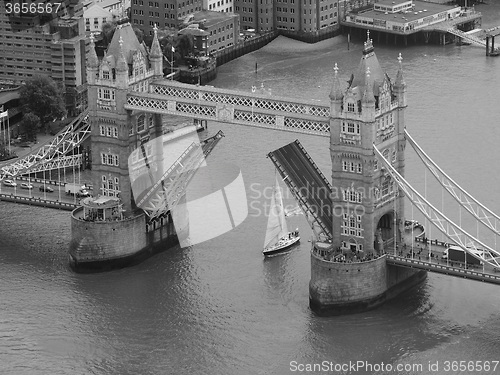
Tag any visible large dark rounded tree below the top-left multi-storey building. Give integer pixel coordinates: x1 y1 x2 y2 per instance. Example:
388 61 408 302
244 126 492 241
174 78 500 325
19 75 66 133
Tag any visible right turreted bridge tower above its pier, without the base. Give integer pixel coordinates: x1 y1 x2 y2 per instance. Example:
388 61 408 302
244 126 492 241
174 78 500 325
330 34 406 256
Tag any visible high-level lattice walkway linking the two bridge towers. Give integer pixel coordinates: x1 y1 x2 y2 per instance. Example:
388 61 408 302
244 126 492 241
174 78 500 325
125 80 330 137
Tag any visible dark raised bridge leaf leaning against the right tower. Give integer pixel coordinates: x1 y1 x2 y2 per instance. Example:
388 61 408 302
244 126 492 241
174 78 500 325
267 140 333 239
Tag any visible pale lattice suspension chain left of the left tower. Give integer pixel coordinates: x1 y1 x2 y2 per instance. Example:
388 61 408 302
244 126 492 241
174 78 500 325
0 110 90 180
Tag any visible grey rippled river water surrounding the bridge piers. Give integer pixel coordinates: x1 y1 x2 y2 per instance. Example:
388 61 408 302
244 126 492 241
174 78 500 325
0 4 500 375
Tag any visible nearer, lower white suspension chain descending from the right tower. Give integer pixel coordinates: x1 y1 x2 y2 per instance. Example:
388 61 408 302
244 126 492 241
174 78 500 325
373 145 500 269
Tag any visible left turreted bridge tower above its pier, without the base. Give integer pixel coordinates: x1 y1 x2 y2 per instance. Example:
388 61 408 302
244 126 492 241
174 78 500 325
87 24 163 212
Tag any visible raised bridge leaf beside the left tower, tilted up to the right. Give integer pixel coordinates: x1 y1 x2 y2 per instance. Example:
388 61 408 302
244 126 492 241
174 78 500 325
137 131 224 220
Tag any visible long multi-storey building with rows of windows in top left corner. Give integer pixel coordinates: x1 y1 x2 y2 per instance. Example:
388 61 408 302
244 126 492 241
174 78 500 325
0 0 87 115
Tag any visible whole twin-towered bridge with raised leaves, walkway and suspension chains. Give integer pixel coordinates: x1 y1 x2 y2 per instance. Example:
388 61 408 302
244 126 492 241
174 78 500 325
0 25 500 314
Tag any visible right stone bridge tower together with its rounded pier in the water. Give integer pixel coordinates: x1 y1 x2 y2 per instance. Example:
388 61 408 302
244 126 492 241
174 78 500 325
309 36 427 315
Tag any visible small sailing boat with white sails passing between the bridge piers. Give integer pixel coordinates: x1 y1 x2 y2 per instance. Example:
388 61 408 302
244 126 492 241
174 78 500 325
262 178 300 256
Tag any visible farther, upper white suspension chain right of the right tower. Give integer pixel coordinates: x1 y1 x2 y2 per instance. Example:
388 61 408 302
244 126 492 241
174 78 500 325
405 130 500 235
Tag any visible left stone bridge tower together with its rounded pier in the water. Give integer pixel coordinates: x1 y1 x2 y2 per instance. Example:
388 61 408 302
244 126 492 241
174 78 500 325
69 24 177 272
